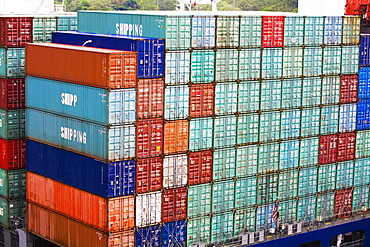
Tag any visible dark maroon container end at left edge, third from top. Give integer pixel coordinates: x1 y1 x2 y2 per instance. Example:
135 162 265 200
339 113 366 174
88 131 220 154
0 78 26 110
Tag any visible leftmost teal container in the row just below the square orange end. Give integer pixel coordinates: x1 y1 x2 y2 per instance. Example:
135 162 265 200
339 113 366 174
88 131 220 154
212 148 236 181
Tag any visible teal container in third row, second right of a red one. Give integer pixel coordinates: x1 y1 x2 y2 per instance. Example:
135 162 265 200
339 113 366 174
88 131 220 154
238 81 261 113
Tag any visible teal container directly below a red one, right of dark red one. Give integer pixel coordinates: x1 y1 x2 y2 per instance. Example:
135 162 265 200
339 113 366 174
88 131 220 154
187 183 212 219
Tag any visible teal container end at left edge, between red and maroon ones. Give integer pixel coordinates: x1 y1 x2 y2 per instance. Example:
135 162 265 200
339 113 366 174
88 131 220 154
0 48 26 78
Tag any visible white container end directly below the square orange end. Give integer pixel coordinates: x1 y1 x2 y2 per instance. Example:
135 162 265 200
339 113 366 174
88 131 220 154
163 154 188 189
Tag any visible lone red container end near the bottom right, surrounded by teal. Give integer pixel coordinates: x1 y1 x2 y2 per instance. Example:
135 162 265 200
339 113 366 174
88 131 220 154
334 188 353 218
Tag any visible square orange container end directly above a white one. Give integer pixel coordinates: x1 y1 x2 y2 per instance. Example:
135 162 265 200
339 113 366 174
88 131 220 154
163 120 189 154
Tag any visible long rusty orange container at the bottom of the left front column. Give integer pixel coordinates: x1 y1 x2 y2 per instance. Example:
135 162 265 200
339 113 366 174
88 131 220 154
27 203 135 247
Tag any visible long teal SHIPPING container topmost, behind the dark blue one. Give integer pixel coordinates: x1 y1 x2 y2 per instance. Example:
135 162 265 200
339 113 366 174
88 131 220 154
77 11 192 50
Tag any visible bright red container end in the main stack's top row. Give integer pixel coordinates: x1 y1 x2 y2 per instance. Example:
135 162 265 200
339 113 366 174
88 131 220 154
262 16 285 48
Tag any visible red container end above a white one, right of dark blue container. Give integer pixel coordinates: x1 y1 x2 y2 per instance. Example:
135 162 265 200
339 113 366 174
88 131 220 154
136 157 163 194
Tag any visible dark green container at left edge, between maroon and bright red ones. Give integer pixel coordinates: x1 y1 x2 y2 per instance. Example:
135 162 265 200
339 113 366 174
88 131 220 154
0 109 26 140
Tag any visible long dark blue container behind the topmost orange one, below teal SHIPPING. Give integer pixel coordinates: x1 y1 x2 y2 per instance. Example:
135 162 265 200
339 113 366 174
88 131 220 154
52 31 165 79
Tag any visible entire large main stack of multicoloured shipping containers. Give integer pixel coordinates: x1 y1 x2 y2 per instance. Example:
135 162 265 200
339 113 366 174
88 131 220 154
23 11 370 246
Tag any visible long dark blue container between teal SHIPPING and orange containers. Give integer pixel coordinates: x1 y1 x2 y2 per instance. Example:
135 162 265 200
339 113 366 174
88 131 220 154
26 140 136 198
